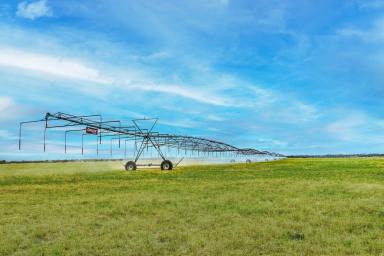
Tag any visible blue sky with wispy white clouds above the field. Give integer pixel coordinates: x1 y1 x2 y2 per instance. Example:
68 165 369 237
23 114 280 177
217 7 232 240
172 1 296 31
0 0 384 159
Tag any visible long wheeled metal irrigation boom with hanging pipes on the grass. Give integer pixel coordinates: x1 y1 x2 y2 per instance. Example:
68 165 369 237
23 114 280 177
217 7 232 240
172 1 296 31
19 112 283 170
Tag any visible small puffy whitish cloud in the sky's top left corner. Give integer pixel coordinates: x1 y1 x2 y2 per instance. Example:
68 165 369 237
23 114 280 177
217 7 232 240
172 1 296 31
16 0 52 20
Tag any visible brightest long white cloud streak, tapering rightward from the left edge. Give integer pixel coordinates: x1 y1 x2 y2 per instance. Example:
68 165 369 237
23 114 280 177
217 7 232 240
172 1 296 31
0 48 231 106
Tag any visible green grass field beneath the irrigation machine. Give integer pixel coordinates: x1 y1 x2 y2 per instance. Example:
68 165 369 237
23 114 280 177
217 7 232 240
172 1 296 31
0 158 384 255
